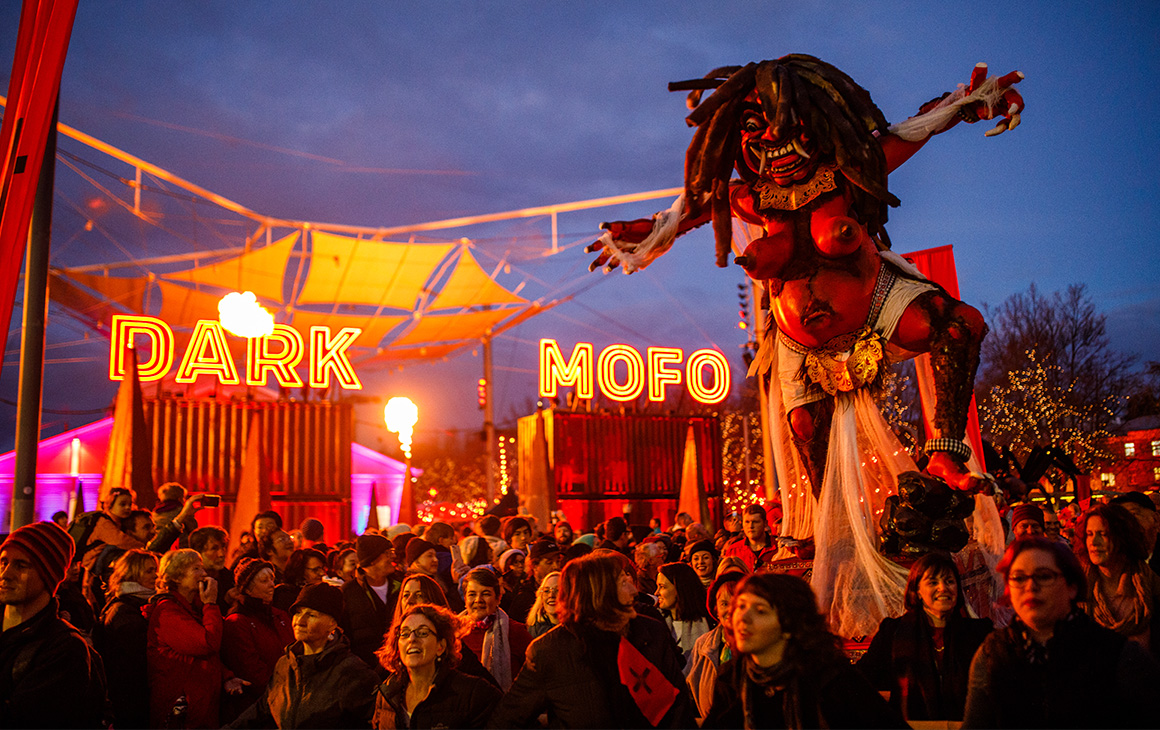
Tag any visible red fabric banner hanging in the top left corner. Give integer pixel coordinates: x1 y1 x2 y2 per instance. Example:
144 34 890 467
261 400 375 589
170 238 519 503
0 0 78 373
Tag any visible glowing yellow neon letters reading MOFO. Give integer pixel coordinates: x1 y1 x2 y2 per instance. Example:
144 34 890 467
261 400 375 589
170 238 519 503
539 339 730 405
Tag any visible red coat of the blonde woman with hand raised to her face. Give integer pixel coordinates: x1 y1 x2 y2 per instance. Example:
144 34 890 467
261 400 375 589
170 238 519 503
144 593 233 728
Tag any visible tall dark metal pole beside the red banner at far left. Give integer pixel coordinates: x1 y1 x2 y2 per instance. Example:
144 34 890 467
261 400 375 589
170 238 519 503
12 99 60 529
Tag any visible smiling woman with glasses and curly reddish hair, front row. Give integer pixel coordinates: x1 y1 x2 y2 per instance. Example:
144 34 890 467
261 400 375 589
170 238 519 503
371 603 501 730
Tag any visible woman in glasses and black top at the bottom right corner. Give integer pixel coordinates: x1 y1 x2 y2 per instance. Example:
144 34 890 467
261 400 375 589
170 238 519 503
963 537 1160 728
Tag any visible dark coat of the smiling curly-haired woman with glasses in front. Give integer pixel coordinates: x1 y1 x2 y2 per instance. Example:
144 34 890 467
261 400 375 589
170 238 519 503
370 667 503 730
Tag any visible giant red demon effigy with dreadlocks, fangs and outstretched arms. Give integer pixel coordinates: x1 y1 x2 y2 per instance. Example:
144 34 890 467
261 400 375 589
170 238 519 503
589 53 1023 636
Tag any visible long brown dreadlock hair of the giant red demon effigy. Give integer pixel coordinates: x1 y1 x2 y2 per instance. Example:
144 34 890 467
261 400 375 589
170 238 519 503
668 53 899 266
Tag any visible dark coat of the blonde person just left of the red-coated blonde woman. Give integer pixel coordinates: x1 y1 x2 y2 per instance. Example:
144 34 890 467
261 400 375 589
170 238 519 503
93 584 153 729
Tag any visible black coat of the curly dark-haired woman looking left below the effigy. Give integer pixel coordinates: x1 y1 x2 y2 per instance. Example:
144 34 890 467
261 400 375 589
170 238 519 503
703 655 909 728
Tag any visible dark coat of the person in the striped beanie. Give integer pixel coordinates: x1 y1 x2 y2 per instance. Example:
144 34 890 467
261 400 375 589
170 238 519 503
0 598 108 728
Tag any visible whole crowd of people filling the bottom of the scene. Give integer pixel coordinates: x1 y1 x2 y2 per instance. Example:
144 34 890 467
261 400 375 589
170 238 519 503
0 484 1160 730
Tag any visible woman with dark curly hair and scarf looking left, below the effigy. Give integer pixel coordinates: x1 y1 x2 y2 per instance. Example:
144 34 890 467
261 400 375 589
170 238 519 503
703 573 909 729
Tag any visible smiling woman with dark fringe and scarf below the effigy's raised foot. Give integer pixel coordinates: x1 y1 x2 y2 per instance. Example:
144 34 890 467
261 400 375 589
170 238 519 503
857 552 993 721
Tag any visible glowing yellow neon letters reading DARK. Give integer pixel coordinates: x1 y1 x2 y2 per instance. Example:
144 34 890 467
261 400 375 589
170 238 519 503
109 315 362 390
